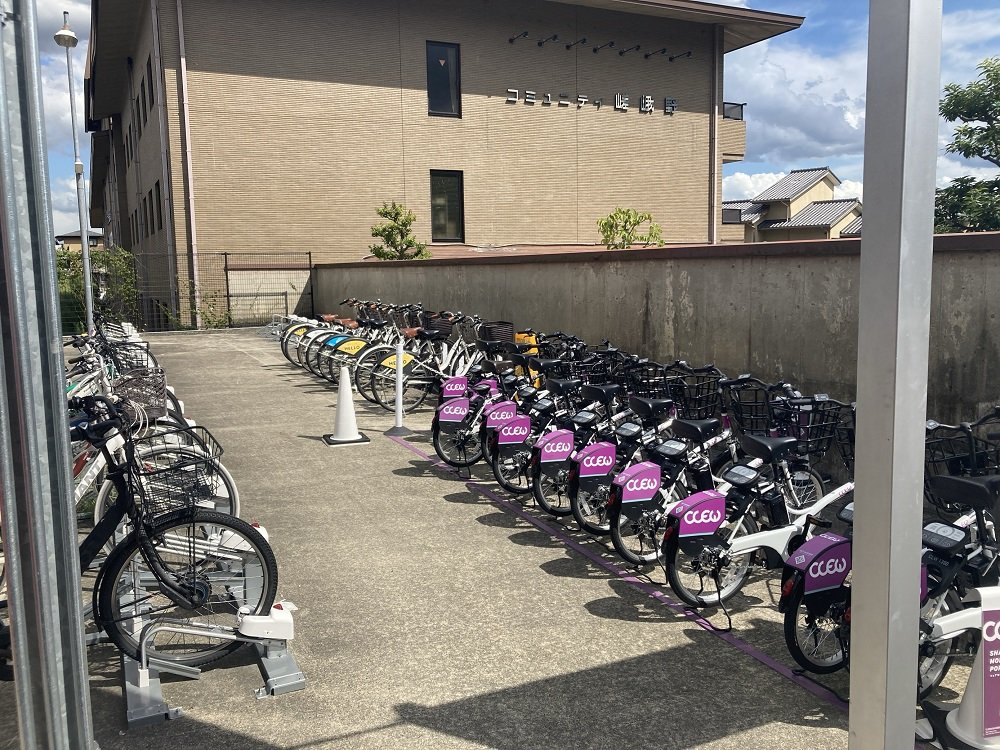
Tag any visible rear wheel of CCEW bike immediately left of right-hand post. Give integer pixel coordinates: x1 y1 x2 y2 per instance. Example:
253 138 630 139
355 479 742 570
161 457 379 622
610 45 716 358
785 586 850 674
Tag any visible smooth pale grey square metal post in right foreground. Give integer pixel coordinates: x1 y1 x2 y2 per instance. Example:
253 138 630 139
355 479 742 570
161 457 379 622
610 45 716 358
849 0 941 750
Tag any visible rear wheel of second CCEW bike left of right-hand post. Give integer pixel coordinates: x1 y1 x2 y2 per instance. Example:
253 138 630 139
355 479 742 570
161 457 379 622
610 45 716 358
667 516 757 607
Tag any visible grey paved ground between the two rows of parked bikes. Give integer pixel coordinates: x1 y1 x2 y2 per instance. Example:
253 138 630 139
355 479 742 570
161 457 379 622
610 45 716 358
0 330 962 750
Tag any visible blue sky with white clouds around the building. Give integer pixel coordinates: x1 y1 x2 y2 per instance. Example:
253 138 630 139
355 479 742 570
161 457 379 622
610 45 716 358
37 0 1000 234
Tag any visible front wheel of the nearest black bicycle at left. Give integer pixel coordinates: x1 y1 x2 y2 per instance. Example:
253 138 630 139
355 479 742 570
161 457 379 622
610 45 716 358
96 509 278 667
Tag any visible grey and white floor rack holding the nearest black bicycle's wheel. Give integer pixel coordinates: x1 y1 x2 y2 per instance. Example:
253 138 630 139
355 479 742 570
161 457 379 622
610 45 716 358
122 602 306 729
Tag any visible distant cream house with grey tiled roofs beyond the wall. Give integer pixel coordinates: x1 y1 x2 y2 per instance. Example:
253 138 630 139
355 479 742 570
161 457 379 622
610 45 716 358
722 167 861 242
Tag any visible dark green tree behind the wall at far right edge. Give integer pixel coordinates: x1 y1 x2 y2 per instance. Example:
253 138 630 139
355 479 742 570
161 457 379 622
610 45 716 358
934 57 1000 232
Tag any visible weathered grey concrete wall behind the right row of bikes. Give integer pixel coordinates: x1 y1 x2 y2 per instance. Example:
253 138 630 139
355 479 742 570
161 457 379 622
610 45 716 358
315 233 1000 422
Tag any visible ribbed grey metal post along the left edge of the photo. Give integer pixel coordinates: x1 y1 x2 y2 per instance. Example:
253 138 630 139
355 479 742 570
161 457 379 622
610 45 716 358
0 0 93 750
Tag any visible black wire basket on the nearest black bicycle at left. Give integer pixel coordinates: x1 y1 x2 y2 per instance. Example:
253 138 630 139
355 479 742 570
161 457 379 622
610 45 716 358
132 427 226 520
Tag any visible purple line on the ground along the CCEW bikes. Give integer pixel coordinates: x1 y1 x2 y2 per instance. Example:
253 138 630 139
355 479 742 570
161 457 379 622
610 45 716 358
388 435 847 711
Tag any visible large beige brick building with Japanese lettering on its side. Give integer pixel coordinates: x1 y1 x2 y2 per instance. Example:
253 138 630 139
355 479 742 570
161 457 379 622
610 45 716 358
86 0 802 324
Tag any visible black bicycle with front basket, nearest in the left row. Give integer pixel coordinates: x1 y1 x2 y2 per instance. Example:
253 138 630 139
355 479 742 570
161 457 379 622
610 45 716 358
70 396 278 667
